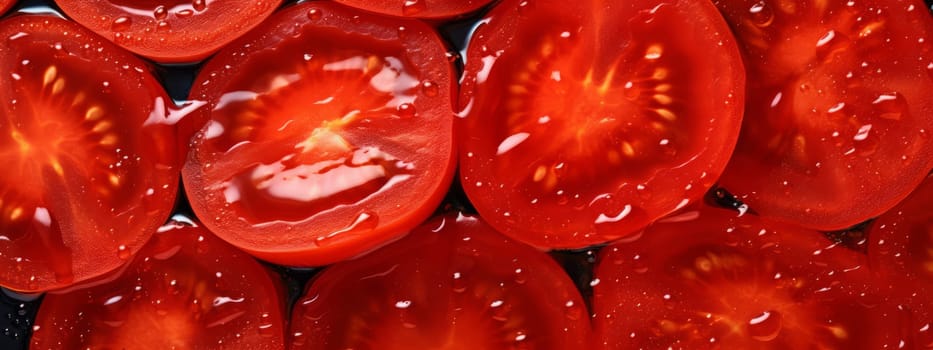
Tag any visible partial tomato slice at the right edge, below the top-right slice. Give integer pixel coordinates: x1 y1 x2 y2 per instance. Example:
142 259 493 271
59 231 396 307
868 177 933 349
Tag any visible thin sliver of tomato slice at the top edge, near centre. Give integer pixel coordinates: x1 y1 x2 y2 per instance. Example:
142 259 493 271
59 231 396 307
336 0 492 19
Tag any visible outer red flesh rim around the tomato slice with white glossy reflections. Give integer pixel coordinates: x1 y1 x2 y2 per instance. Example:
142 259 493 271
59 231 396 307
182 2 456 266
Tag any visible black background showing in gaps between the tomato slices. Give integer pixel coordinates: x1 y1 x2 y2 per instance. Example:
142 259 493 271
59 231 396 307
0 0 933 350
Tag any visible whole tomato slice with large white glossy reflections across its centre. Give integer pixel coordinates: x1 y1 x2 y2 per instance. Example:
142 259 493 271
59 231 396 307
183 2 455 266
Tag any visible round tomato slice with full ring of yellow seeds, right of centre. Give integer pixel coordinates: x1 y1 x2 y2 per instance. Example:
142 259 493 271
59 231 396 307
458 0 745 248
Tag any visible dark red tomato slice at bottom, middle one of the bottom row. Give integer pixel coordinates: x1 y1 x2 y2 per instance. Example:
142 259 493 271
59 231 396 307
289 215 590 350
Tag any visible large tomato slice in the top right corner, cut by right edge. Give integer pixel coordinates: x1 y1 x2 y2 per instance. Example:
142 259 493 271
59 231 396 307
716 0 933 230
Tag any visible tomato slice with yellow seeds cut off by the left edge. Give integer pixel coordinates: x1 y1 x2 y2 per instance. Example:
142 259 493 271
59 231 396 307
0 15 180 292
